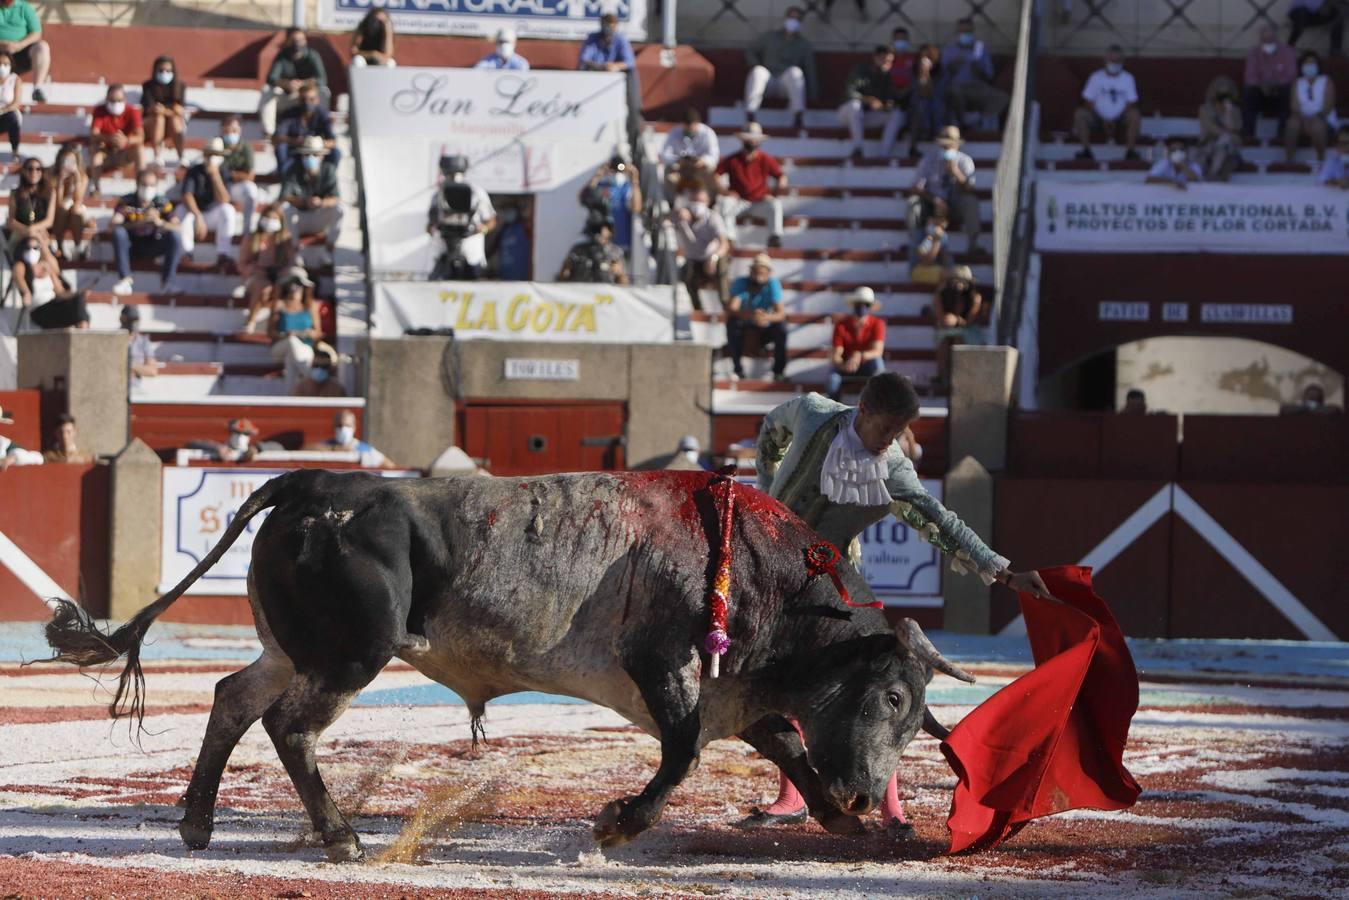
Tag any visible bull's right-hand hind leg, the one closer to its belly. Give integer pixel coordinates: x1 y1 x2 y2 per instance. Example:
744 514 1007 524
262 666 389 862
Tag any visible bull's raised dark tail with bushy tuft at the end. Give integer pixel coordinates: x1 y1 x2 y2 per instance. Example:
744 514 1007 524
40 472 299 726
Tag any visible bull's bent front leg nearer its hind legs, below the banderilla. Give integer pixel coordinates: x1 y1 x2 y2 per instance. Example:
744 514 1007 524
594 657 701 849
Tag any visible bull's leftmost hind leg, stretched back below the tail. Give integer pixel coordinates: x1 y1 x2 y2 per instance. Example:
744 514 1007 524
178 650 295 850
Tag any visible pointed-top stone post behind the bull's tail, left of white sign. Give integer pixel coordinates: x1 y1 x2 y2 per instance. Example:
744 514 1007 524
108 437 163 619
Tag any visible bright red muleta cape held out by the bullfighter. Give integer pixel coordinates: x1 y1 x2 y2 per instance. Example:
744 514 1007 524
942 565 1140 853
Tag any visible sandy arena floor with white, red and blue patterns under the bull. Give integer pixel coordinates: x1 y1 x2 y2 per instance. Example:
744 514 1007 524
0 625 1349 899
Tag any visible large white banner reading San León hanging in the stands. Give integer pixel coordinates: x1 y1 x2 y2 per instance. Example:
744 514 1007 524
351 66 627 277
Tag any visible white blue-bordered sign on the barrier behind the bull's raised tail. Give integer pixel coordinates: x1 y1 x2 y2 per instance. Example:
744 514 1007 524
159 466 420 596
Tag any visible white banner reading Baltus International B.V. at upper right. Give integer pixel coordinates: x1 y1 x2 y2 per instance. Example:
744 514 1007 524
1035 183 1349 254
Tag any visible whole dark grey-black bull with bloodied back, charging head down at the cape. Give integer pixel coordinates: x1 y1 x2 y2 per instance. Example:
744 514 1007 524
47 470 973 860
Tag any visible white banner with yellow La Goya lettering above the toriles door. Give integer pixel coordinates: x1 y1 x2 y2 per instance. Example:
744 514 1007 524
370 281 675 344
